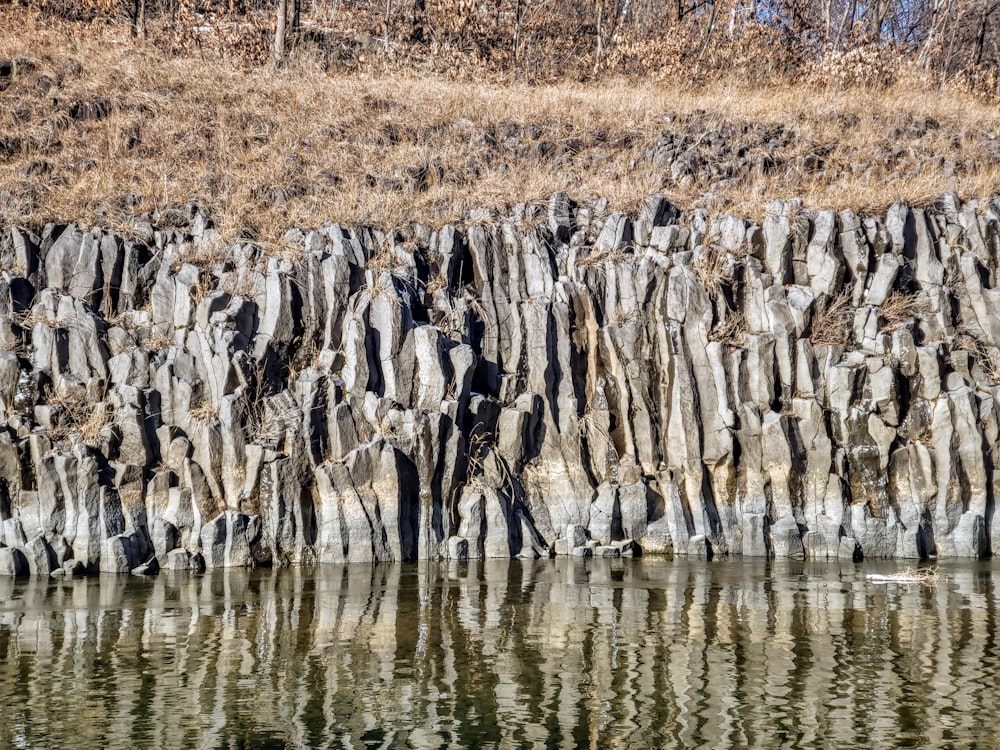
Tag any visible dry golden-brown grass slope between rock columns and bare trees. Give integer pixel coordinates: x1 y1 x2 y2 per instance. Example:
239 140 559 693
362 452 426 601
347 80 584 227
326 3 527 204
0 10 1000 242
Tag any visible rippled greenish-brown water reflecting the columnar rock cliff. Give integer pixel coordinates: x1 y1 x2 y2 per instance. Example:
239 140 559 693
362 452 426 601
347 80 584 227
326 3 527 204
0 559 1000 749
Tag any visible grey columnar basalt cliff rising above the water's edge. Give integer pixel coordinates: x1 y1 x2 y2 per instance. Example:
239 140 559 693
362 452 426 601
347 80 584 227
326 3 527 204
0 195 1000 572
